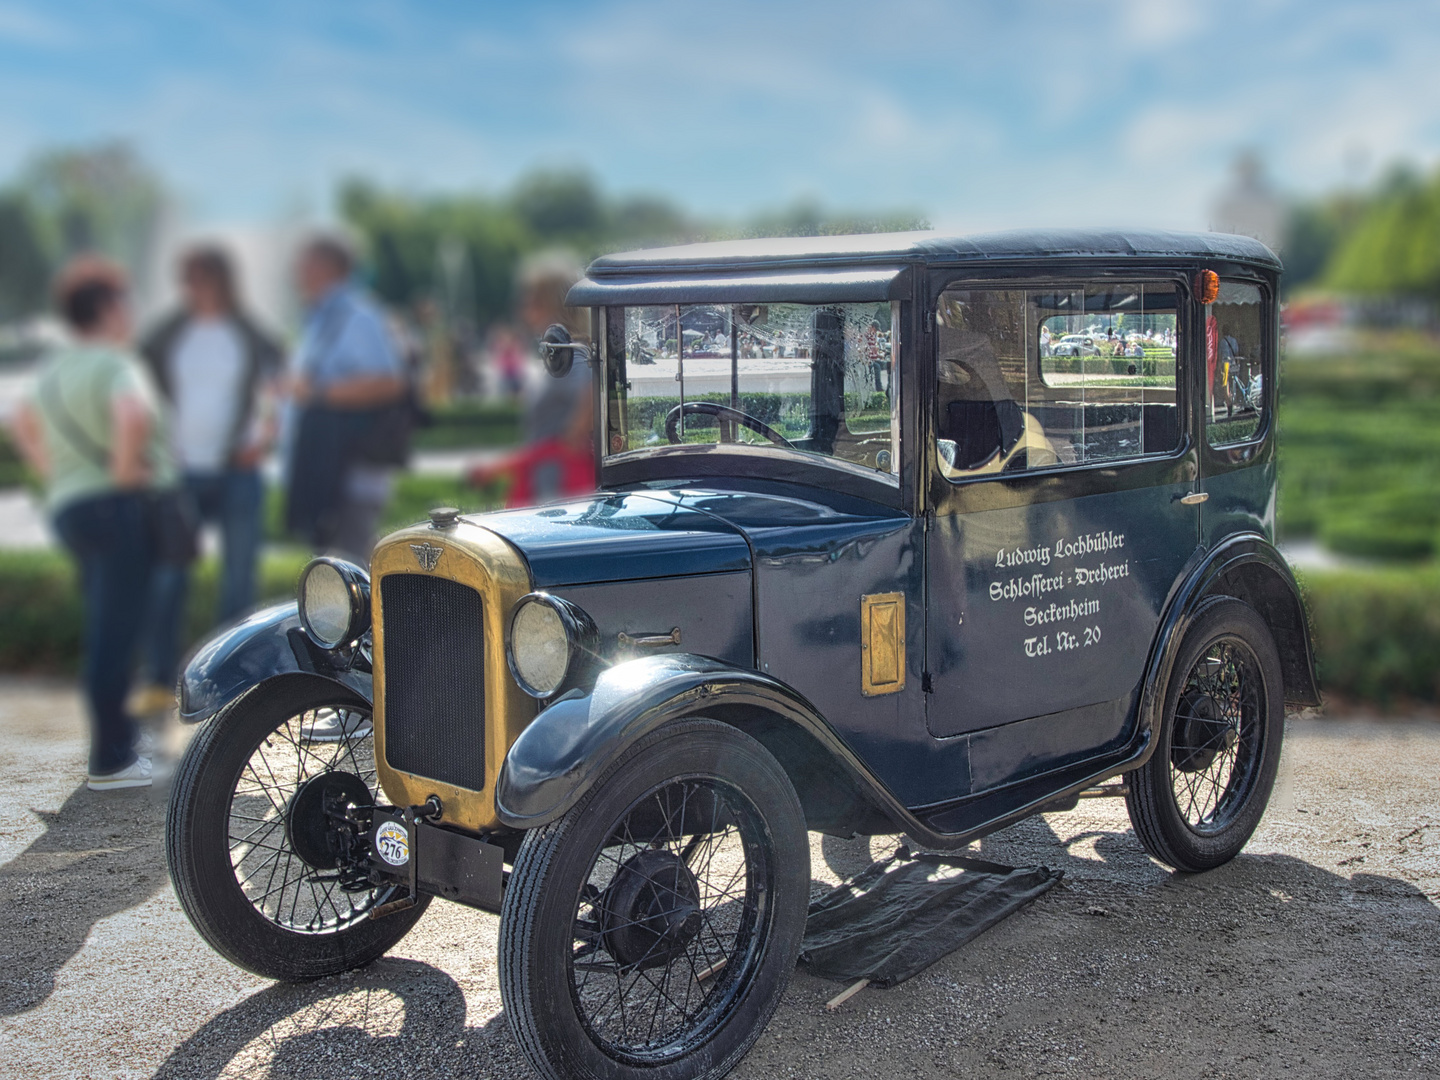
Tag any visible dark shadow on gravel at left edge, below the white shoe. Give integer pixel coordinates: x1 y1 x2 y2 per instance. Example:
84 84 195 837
0 785 167 1017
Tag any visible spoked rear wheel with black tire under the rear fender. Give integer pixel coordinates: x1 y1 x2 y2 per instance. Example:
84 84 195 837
1125 596 1284 873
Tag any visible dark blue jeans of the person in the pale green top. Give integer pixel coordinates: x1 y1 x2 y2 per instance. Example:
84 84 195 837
55 492 153 776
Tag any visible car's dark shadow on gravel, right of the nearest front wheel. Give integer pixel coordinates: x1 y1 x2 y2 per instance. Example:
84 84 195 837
789 814 1440 1077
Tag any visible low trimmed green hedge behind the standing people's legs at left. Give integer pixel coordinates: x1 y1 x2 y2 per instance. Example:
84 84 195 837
0 550 310 672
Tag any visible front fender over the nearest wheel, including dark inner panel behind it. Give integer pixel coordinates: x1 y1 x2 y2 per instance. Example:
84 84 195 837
495 652 898 829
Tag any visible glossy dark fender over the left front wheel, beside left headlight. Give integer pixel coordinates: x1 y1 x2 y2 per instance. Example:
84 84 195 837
180 600 374 724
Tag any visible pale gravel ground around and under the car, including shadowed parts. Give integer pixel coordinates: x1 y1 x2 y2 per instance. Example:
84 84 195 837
0 680 1440 1080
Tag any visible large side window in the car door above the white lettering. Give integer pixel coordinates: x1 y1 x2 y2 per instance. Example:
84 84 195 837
936 282 1181 480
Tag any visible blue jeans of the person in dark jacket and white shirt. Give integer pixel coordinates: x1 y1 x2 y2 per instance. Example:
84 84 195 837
145 469 265 687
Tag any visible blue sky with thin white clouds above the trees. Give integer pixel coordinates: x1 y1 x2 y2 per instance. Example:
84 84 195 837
0 0 1440 232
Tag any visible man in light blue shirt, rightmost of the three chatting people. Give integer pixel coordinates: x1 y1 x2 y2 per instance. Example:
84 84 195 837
285 236 409 564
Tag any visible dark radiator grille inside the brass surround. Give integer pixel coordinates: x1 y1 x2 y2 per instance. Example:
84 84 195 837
380 573 485 791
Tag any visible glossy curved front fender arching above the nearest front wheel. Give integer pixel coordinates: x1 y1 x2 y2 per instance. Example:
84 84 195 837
495 652 887 829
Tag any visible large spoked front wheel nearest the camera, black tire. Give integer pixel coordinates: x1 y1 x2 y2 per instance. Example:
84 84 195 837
500 720 809 1080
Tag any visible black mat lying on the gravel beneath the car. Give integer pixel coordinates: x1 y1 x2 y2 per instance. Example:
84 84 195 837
801 847 1064 986
